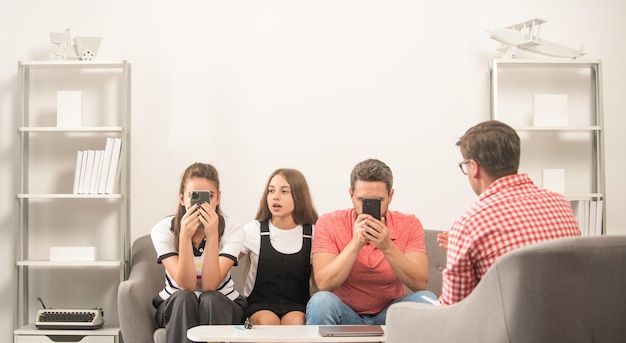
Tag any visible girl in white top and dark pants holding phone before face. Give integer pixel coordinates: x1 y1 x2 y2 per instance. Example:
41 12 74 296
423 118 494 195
151 163 246 343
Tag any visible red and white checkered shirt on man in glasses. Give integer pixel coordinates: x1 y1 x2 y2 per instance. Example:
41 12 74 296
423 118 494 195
439 174 580 305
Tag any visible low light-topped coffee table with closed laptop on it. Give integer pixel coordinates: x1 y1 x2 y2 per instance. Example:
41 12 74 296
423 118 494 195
187 325 386 342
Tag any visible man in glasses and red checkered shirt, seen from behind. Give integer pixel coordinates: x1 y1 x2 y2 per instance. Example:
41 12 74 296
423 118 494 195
438 120 580 305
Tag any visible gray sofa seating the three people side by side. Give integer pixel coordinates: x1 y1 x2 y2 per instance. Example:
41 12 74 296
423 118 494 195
118 230 446 343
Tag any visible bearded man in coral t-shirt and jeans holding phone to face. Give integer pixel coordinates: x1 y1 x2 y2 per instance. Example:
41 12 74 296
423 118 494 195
306 159 437 325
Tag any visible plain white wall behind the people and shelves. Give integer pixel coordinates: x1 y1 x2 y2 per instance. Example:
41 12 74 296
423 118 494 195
0 0 626 341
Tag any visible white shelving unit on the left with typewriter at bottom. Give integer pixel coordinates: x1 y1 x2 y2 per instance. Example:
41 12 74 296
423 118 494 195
14 61 131 343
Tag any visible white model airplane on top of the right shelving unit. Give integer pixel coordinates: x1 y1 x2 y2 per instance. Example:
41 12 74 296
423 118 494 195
485 18 585 59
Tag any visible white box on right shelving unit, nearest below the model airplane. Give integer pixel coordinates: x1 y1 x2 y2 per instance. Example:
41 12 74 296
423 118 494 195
533 94 568 126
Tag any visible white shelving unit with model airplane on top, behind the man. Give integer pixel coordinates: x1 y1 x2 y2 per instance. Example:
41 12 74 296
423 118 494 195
491 59 606 235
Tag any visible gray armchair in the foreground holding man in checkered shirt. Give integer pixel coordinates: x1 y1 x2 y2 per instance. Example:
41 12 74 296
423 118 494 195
386 236 626 343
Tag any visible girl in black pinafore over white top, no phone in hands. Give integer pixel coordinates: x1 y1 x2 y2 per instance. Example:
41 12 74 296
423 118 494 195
242 169 318 325
